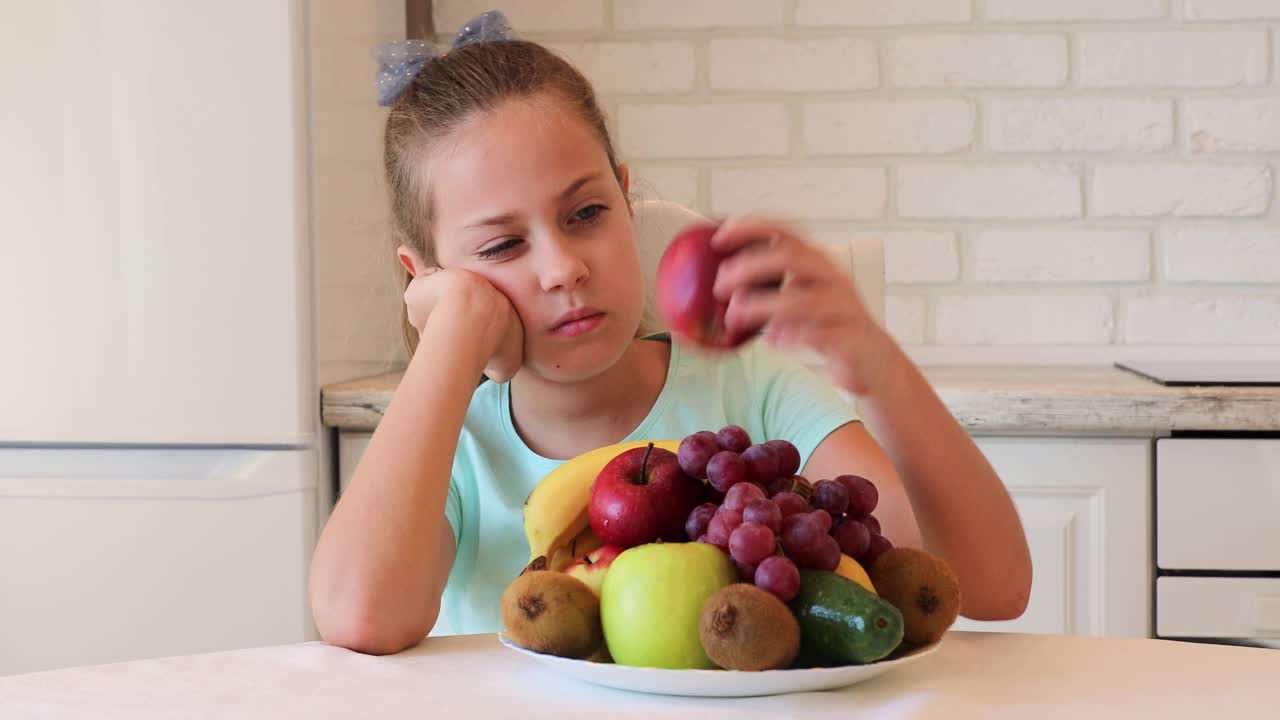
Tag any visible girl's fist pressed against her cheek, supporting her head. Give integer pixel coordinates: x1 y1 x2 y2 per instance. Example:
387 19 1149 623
404 268 525 383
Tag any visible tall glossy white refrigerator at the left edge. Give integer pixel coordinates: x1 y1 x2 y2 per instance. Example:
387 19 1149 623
0 0 320 674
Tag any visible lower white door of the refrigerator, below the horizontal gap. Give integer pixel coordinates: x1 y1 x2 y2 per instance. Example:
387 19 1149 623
0 448 319 671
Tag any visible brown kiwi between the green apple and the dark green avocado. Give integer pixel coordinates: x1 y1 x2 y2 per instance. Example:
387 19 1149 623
698 583 800 670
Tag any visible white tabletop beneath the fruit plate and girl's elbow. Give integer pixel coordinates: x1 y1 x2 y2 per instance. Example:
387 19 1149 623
0 630 1280 720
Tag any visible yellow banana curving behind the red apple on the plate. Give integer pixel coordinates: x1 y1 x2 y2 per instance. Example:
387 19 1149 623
524 439 680 569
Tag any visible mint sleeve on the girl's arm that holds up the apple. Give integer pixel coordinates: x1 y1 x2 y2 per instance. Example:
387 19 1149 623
749 341 860 468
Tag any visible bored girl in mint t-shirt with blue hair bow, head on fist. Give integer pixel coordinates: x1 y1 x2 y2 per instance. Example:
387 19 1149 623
310 15 1032 653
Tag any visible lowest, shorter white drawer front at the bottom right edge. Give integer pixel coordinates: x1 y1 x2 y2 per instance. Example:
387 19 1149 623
1156 578 1280 638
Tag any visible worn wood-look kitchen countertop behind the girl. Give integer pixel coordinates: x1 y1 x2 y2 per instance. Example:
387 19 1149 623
323 365 1280 436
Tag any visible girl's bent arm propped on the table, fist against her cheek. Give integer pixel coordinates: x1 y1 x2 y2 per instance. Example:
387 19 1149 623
310 270 518 655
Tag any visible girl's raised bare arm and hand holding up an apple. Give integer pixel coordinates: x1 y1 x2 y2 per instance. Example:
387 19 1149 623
712 217 1032 620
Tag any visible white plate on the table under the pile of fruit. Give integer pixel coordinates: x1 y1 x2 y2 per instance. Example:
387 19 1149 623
498 633 942 697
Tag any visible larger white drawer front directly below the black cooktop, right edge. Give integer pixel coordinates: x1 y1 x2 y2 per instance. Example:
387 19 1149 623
1156 438 1280 570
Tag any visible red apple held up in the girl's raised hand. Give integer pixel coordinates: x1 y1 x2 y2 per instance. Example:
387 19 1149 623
655 223 759 350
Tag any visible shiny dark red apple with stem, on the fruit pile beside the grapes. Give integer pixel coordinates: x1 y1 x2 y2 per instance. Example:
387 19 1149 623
586 443 703 548
